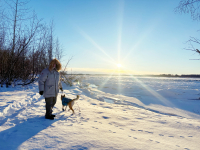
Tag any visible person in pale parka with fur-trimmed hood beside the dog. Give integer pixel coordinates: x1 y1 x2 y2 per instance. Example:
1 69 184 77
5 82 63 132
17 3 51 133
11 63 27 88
38 59 63 120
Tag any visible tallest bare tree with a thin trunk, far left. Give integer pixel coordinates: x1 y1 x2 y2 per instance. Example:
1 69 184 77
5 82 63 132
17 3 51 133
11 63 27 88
2 0 41 87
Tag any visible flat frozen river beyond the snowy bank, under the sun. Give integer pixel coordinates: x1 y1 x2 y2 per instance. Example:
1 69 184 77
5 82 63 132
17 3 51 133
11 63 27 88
80 75 200 114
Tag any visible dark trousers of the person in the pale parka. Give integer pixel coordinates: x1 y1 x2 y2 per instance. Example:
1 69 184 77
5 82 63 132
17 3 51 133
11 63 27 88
45 97 57 116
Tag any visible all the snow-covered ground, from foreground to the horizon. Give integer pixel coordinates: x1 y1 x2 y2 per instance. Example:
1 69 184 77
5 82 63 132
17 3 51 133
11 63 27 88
0 76 200 150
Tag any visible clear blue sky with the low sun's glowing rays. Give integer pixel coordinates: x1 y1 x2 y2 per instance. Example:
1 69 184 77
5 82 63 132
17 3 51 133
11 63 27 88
29 0 200 74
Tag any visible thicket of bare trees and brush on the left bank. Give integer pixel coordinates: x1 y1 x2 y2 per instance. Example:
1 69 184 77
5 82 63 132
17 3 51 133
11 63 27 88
0 0 62 87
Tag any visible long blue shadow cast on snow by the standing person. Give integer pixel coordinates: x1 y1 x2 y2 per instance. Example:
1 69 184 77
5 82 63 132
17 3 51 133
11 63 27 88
0 116 55 150
